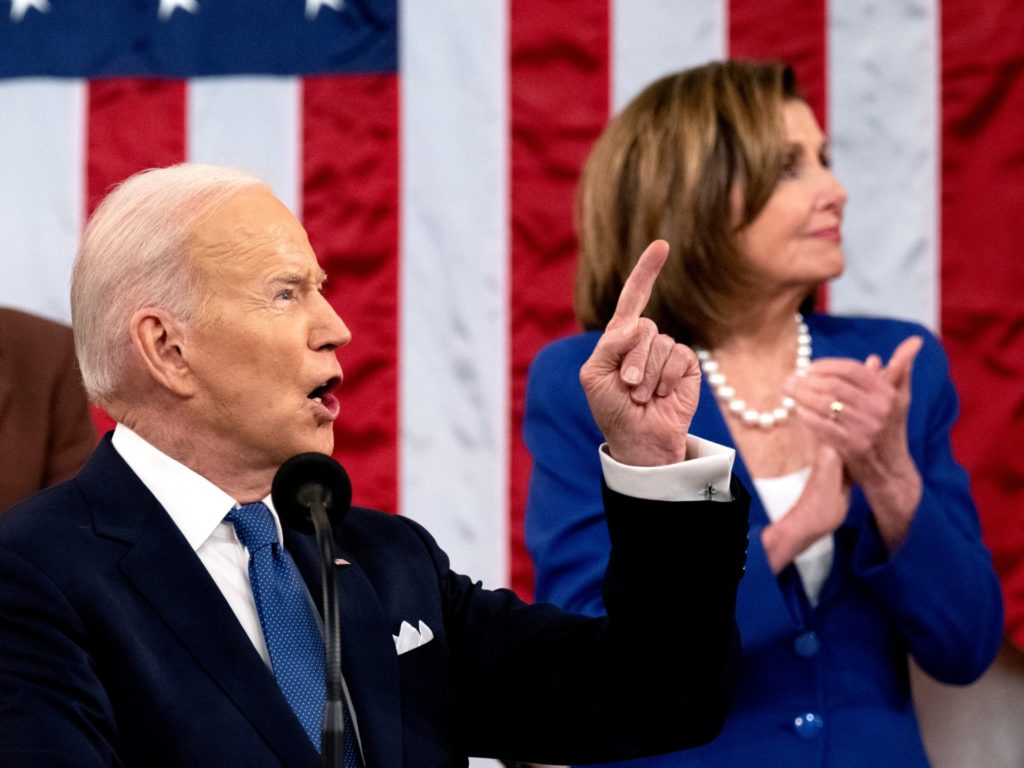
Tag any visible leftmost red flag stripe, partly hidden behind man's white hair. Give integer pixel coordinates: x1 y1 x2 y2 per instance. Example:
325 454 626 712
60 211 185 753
85 78 185 433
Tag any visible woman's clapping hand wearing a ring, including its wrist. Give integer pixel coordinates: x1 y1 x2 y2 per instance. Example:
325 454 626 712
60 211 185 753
787 336 922 551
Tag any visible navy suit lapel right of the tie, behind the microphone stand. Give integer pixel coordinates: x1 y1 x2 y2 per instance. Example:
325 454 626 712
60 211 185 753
285 524 403 768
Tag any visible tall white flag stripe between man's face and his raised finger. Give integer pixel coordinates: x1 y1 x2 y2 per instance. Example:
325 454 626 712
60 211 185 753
399 0 509 587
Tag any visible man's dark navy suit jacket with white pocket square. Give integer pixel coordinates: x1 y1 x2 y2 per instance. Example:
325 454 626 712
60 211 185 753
0 436 748 768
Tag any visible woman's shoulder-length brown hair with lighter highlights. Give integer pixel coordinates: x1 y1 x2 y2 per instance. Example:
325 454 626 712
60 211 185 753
575 60 802 346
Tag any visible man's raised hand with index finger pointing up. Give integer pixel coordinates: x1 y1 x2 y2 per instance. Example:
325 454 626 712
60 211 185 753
580 240 700 467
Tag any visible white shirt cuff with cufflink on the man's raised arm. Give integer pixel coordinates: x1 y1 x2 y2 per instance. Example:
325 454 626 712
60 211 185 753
599 435 736 502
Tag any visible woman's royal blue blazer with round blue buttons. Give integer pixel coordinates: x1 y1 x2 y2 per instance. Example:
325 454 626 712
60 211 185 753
523 314 1002 768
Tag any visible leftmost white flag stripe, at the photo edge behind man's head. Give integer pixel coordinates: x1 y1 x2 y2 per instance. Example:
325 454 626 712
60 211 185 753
0 79 85 323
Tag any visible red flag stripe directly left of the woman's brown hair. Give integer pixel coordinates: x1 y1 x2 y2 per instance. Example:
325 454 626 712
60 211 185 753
509 0 609 596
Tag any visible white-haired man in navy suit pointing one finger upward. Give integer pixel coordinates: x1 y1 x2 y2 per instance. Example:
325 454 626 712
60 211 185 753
0 164 748 768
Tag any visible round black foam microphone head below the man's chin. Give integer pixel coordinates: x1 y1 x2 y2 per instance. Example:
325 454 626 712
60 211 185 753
270 453 352 534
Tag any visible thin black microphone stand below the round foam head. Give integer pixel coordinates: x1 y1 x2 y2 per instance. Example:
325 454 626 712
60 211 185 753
309 499 345 768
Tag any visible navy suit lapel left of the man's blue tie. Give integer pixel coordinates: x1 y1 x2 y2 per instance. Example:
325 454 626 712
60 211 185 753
78 435 318 766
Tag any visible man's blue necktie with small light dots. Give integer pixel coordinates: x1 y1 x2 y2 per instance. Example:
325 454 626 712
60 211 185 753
224 502 359 768
